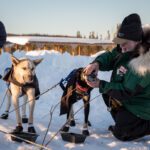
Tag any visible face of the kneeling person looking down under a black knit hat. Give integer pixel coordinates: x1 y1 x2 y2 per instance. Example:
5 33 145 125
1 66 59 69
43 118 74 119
120 41 139 53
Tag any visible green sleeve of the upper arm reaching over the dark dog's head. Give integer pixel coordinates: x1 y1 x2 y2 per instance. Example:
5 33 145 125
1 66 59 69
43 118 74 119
93 47 120 71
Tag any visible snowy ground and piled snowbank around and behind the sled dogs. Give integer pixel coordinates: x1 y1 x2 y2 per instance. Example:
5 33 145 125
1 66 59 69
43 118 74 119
0 50 150 150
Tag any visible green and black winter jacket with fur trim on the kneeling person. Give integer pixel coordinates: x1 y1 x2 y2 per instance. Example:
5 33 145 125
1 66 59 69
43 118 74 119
94 47 150 120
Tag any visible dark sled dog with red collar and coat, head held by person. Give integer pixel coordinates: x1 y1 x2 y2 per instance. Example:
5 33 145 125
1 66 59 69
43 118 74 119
60 68 95 135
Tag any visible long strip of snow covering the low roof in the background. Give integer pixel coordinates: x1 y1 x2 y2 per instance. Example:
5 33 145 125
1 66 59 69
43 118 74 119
7 36 112 45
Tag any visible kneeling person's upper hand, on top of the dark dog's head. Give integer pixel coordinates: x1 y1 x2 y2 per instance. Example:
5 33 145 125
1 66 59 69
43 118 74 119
84 62 99 75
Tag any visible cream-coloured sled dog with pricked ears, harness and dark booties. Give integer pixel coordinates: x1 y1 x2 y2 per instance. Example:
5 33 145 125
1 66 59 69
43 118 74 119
6 55 43 133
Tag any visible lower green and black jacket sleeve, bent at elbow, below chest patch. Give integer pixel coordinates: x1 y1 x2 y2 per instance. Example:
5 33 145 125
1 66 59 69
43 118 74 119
99 70 146 101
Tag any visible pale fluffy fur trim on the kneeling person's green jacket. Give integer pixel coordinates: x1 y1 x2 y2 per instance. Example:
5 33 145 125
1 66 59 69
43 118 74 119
129 47 150 76
